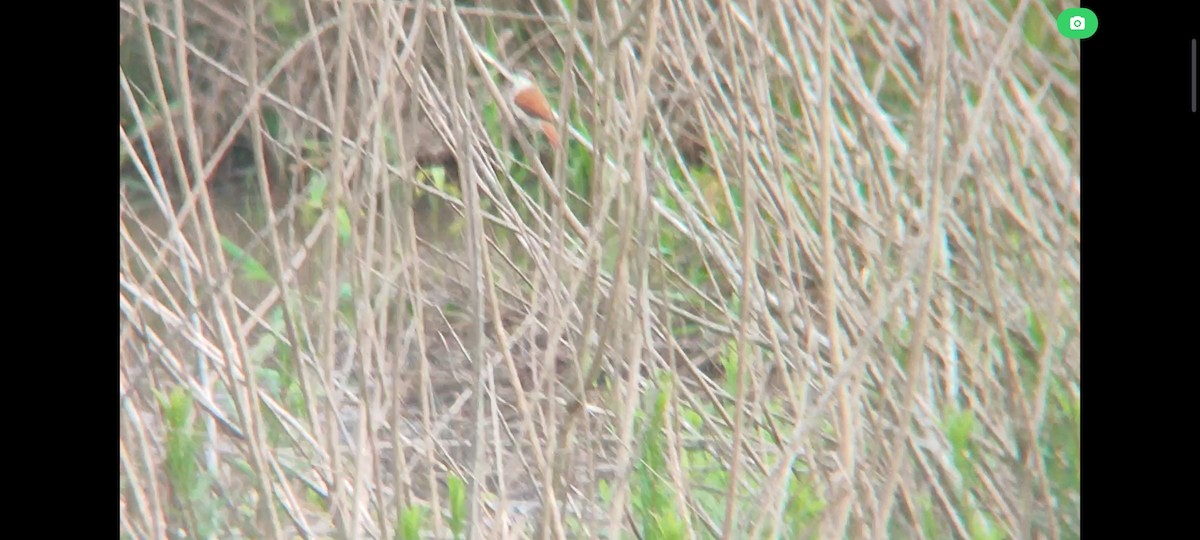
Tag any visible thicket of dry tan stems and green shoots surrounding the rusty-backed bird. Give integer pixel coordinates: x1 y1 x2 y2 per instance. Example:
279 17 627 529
120 0 1080 540
